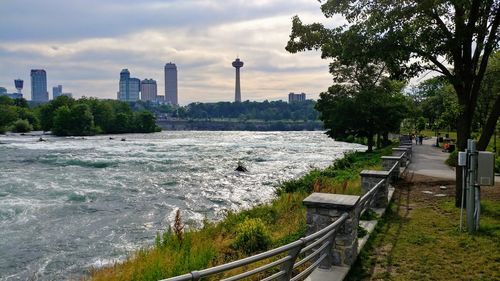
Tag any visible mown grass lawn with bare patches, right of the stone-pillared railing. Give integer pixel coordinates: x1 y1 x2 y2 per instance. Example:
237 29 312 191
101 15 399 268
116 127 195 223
347 179 500 280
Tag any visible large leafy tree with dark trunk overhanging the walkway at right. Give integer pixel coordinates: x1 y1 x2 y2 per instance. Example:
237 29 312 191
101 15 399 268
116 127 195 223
287 0 500 205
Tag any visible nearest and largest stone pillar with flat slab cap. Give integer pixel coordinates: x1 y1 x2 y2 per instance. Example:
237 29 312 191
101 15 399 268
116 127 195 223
303 193 360 268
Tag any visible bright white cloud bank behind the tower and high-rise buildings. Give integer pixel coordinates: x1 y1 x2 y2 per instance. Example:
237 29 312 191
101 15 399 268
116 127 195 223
0 0 341 104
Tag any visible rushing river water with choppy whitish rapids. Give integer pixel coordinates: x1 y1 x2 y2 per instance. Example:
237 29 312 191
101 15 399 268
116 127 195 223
0 131 365 280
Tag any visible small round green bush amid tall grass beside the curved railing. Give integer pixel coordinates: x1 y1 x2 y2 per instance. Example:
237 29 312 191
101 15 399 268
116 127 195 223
233 218 271 254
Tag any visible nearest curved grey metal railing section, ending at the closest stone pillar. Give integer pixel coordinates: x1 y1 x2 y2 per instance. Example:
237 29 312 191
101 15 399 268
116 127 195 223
160 213 348 281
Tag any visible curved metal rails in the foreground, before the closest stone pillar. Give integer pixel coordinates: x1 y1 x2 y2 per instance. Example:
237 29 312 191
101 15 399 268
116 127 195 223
160 213 348 281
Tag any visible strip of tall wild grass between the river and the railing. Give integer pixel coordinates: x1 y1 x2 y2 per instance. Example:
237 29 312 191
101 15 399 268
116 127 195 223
89 143 392 280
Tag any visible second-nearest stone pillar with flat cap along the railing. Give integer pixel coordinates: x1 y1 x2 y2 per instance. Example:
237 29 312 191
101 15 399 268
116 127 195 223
359 170 394 208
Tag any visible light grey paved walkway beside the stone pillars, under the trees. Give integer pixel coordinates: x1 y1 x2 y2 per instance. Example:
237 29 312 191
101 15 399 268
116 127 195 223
408 137 455 179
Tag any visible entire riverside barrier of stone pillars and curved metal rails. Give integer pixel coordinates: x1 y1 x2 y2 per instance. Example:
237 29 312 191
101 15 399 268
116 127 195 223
157 138 412 281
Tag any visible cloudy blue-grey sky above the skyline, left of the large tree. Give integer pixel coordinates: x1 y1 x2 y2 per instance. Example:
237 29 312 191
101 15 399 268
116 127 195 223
0 0 343 105
